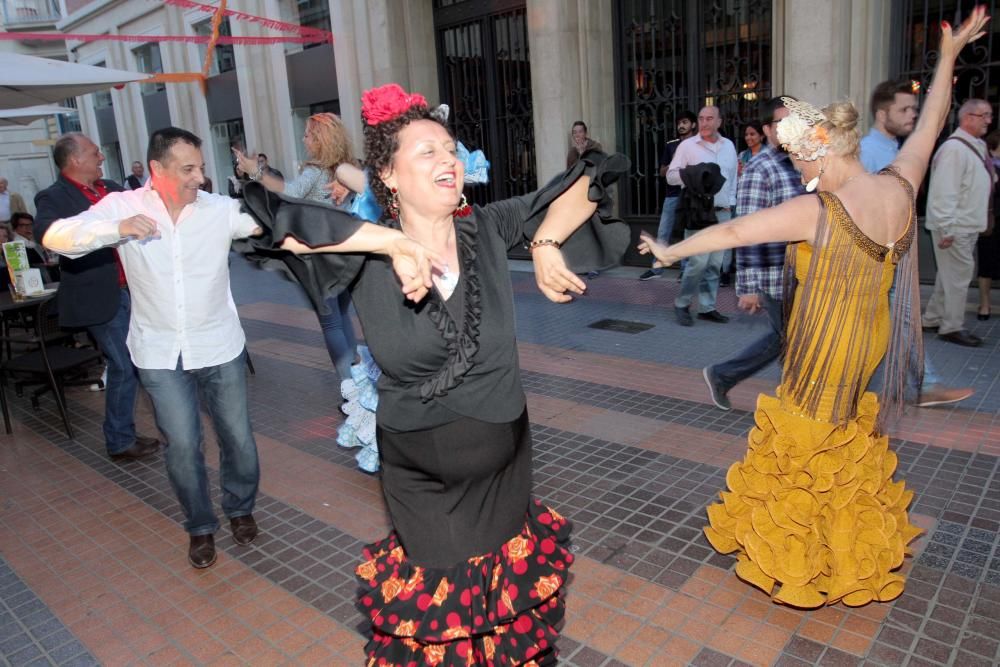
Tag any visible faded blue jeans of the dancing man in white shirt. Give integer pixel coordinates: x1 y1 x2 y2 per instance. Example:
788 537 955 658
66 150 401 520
139 351 260 535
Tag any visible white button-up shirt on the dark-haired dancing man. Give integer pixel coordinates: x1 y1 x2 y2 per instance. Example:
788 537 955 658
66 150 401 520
43 183 257 370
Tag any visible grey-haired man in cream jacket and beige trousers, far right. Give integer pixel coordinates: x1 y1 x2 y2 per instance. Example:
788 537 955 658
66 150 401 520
923 99 996 347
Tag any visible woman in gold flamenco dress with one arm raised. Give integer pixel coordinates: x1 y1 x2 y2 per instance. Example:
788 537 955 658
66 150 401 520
639 7 988 608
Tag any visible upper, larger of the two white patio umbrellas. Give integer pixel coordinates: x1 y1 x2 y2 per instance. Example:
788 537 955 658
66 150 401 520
0 52 150 109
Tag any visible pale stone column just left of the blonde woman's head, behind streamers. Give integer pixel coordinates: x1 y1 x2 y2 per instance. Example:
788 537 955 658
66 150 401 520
229 0 300 177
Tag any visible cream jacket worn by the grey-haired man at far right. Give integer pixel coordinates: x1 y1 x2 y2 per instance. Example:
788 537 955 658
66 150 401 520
927 128 992 236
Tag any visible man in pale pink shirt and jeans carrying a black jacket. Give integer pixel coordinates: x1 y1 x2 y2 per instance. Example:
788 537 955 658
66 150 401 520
667 106 738 327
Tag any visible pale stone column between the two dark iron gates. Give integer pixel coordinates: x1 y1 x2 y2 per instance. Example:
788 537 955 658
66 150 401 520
527 0 617 183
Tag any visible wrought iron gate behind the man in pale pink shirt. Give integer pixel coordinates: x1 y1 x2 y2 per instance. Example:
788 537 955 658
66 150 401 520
614 0 772 231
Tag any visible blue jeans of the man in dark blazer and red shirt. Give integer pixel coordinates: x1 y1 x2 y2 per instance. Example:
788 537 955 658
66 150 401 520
87 289 139 455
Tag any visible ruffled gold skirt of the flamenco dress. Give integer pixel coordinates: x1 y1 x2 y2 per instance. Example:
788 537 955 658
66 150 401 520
705 393 921 609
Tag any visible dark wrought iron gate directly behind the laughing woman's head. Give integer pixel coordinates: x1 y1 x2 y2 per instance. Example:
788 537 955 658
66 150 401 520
434 0 537 203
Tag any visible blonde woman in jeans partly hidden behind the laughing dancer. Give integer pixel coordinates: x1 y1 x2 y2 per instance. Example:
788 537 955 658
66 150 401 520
232 113 375 434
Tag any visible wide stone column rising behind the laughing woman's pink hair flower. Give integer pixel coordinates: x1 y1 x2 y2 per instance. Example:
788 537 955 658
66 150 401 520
330 0 440 153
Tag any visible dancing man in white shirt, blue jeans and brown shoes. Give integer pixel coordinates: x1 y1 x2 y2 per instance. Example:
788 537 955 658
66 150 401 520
43 127 260 568
